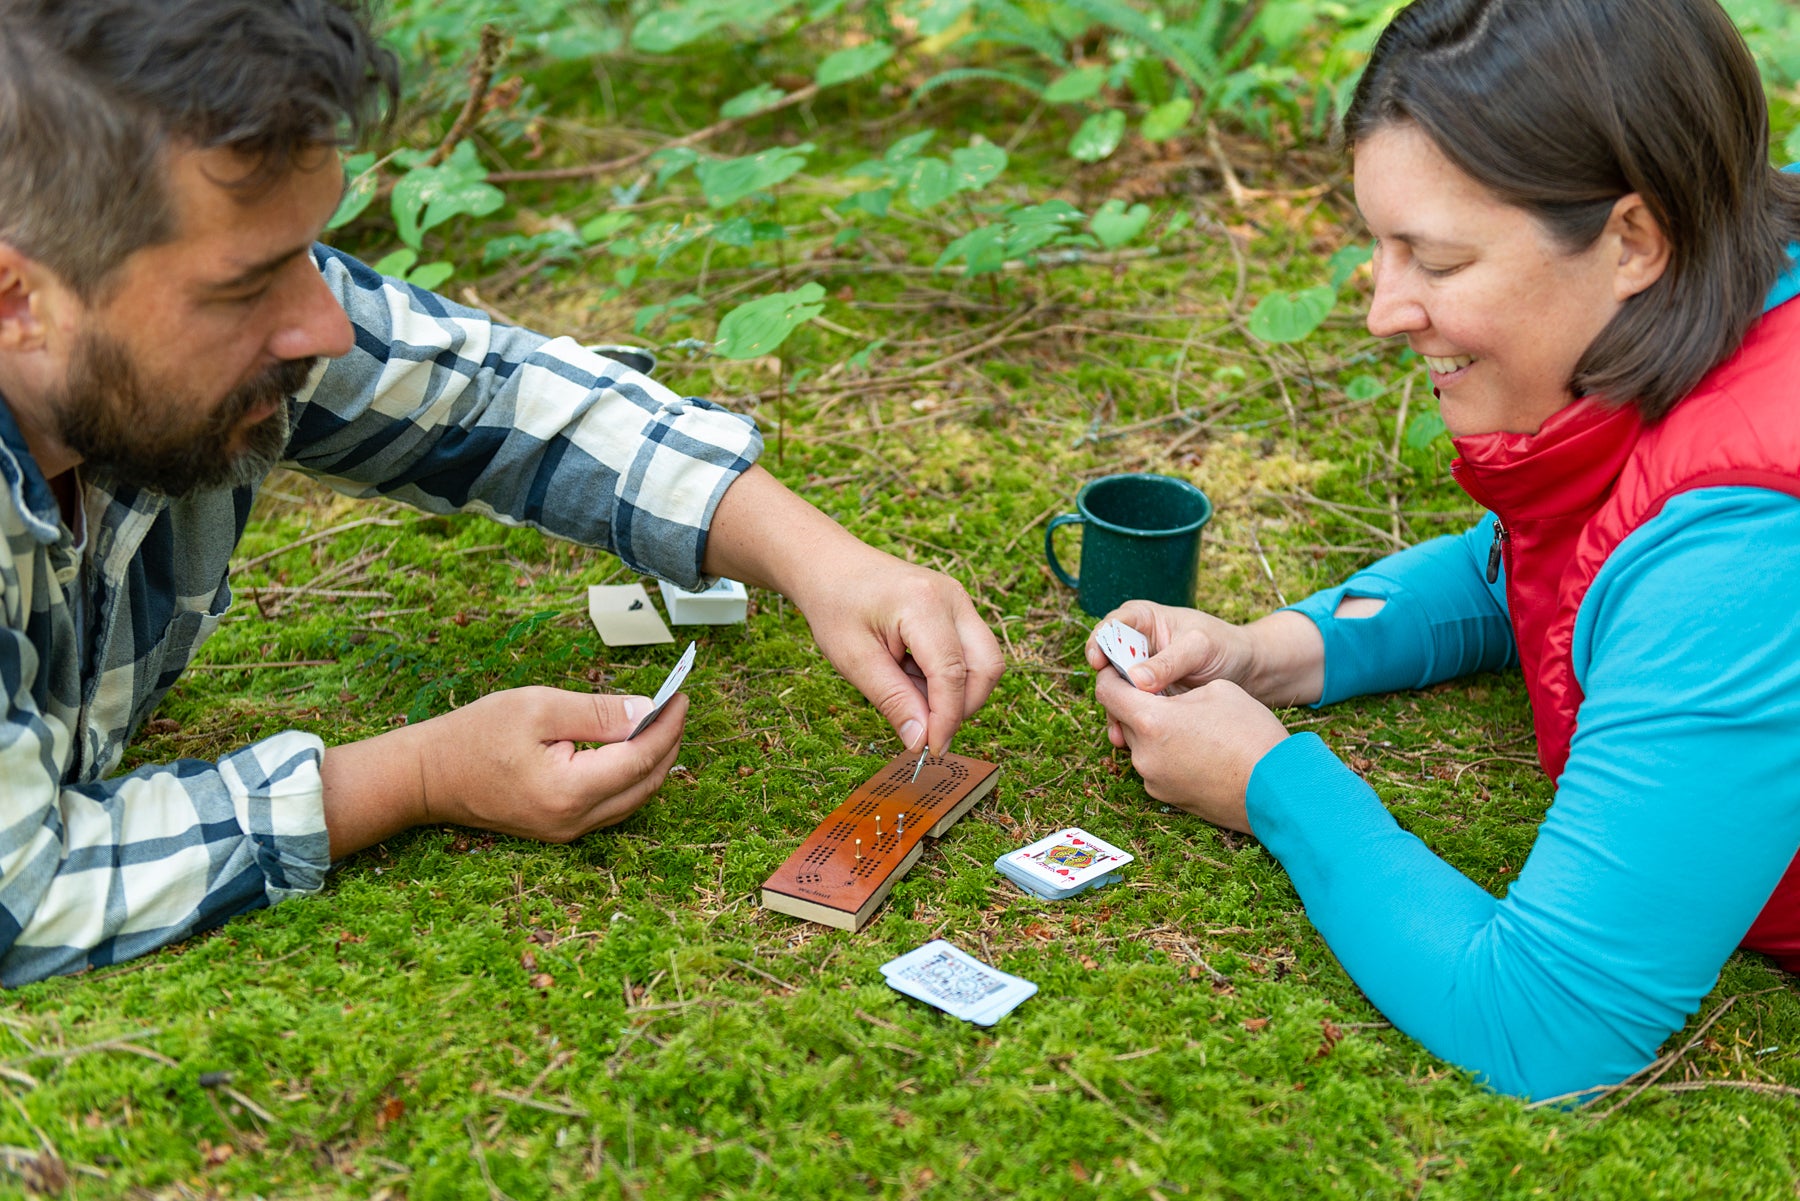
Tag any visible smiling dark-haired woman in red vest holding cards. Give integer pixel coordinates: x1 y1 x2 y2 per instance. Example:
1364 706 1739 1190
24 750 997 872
1087 0 1800 1098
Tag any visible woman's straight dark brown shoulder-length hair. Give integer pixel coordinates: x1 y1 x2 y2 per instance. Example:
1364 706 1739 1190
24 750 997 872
1345 0 1800 421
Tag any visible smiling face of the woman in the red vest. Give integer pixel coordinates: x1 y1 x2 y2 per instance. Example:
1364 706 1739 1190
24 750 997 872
1355 122 1645 438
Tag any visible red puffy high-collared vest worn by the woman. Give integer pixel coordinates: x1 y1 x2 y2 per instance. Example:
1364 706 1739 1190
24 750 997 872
1451 301 1800 971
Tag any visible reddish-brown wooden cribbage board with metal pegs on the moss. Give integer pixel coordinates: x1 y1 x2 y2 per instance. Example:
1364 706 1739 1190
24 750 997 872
763 754 1001 931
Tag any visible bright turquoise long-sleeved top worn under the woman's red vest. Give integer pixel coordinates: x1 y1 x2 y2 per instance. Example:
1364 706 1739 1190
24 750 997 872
1246 248 1800 1097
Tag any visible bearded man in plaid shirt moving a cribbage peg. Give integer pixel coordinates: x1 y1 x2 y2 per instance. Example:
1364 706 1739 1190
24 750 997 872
0 0 1001 983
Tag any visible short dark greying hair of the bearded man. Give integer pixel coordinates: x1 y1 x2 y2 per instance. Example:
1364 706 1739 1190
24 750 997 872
0 0 400 301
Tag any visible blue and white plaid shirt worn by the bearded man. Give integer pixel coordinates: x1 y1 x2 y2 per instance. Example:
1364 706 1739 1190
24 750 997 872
0 247 761 985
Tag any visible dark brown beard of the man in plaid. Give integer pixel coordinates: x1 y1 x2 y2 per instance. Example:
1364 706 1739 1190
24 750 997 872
52 330 319 497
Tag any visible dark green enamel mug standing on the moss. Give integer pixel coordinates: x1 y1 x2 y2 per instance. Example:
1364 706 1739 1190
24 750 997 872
1044 474 1213 618
